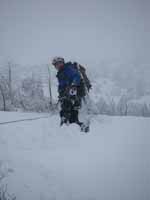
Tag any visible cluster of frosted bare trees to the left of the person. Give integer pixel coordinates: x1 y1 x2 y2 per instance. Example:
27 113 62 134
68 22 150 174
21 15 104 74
0 62 50 112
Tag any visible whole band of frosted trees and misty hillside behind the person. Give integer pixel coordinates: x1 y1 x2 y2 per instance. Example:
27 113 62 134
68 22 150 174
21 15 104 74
0 62 150 117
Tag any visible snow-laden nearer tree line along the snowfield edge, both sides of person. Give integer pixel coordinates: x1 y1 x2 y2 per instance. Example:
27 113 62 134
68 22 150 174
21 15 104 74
0 63 150 117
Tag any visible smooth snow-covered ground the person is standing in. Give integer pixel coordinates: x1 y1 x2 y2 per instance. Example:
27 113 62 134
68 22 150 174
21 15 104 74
0 112 150 200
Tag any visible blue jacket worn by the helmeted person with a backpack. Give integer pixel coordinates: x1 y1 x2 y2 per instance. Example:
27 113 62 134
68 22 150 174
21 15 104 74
57 62 81 91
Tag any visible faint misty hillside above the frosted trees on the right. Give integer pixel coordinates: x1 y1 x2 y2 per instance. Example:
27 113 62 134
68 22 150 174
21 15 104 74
91 59 150 98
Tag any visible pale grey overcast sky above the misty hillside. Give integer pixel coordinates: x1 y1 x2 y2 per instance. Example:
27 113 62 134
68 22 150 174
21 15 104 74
0 0 150 64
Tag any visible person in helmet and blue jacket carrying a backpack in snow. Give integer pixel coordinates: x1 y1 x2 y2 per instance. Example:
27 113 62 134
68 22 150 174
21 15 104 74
52 57 91 129
